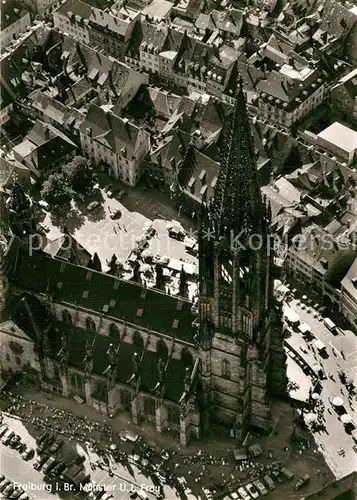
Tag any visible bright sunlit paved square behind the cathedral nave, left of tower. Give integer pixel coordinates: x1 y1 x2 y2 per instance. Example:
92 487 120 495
42 186 197 271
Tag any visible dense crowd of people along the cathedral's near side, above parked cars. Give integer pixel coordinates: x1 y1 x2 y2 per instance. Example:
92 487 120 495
1 386 322 495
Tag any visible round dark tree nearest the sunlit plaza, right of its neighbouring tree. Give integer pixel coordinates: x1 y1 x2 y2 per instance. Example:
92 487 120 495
62 156 97 195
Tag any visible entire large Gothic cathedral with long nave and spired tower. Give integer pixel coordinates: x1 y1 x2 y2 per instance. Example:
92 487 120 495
0 82 287 445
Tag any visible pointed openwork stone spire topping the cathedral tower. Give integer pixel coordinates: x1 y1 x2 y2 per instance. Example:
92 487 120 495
211 78 264 237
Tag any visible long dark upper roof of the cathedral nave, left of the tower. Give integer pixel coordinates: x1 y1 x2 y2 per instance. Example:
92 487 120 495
5 239 196 343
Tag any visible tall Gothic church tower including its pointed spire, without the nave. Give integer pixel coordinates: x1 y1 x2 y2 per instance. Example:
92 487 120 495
199 81 285 437
